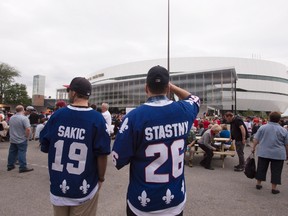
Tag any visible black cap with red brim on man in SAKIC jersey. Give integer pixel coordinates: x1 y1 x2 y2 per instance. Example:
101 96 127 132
65 77 92 96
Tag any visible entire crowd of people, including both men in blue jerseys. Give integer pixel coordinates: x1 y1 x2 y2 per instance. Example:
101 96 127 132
0 66 288 216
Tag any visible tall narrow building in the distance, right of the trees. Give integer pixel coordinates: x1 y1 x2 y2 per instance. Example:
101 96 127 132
32 75 45 107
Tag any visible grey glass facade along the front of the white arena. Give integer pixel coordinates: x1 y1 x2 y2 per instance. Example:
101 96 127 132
85 69 237 110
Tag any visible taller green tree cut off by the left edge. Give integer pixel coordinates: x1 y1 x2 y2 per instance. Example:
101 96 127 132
0 63 20 104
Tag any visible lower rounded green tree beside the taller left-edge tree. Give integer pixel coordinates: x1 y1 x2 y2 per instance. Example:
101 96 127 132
5 83 31 106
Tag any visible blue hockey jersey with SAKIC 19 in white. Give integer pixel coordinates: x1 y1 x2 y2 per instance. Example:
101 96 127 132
40 105 110 205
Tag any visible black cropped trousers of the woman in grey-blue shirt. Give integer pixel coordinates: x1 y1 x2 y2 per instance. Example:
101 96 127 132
255 157 284 184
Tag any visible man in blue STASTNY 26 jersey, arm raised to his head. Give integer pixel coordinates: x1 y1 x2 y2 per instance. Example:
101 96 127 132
112 66 200 216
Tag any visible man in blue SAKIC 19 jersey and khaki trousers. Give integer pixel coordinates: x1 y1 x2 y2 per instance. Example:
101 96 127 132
40 77 110 216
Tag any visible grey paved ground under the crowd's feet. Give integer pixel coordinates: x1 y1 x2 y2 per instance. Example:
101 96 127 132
0 141 288 216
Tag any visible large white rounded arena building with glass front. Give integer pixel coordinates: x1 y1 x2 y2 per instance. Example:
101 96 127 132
57 57 288 112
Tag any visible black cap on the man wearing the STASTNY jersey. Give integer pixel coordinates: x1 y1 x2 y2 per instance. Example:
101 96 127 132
146 65 169 86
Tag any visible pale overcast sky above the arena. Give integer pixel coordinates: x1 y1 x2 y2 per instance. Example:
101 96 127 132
0 0 288 98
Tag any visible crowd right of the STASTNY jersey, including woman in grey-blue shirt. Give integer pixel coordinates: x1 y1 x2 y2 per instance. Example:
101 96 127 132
183 112 288 197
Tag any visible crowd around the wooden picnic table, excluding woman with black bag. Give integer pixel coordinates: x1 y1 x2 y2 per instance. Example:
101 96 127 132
187 112 288 167
